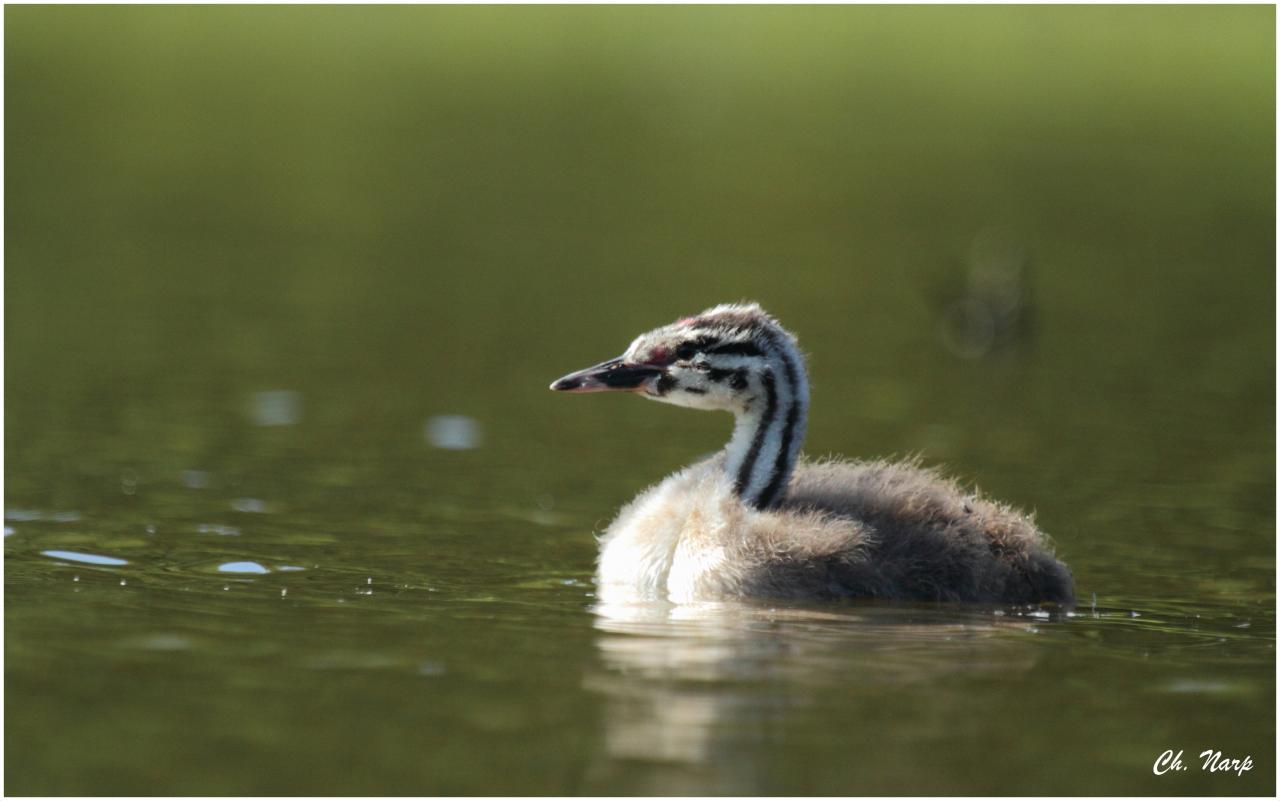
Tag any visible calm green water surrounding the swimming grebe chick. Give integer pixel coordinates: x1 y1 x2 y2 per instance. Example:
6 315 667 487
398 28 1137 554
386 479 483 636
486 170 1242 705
4 6 1276 795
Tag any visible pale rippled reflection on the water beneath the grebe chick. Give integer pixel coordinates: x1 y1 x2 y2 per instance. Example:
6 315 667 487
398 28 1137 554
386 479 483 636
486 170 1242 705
586 603 1038 795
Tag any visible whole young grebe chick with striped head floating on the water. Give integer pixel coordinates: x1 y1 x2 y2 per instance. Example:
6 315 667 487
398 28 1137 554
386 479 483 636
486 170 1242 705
550 302 1074 607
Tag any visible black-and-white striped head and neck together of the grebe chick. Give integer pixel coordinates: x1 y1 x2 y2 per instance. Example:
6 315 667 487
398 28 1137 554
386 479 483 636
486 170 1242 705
552 303 809 508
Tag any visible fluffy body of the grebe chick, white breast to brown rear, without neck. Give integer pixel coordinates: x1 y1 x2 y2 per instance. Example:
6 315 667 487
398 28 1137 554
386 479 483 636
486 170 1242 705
599 454 1073 604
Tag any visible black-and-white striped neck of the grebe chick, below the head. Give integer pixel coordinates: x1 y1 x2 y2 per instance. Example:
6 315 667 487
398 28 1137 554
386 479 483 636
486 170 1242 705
724 342 809 509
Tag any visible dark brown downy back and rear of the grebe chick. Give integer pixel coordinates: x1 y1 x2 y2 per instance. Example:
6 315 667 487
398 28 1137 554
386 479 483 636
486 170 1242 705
756 452 1074 604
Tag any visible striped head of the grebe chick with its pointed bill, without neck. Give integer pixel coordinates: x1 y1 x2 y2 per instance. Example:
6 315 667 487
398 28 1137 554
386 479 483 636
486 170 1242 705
552 303 808 413
